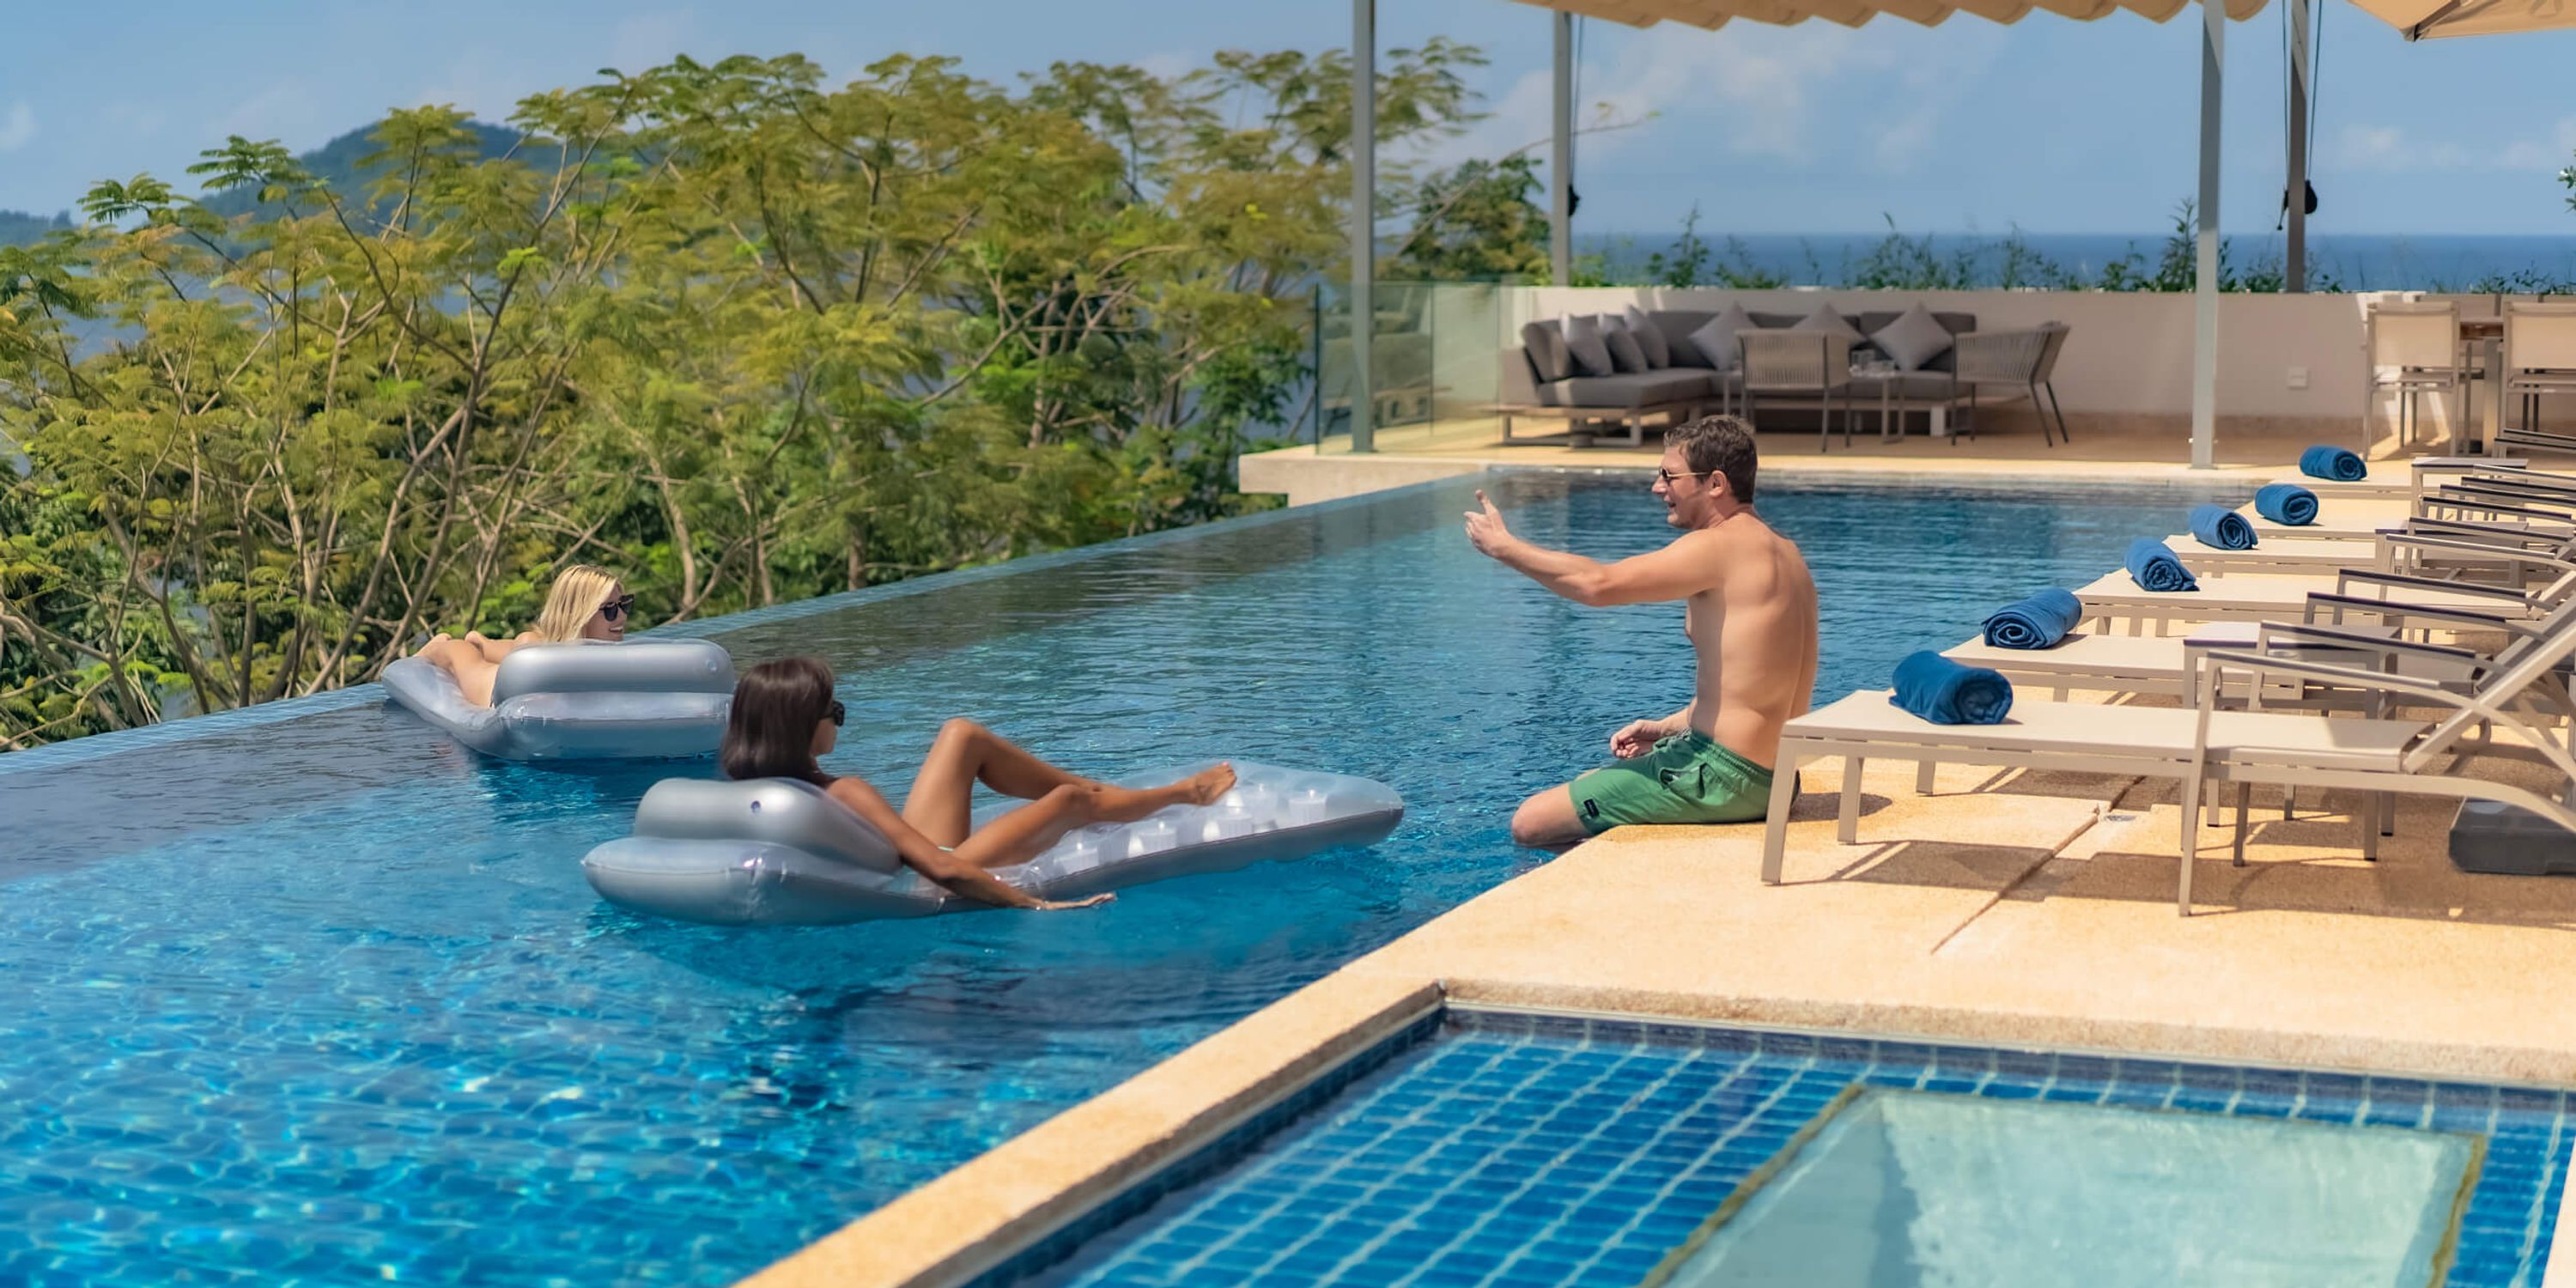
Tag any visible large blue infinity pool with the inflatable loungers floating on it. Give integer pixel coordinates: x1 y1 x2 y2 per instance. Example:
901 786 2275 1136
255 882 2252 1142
0 474 2236 1283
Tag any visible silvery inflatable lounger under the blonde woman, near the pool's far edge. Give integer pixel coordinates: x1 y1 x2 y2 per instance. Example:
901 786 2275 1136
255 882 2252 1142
384 639 734 760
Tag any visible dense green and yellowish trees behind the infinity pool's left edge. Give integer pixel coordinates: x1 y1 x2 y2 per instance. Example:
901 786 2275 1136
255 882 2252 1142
0 41 1479 747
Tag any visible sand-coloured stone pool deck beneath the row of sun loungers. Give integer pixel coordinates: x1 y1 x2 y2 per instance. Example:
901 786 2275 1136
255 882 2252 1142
750 732 2576 1288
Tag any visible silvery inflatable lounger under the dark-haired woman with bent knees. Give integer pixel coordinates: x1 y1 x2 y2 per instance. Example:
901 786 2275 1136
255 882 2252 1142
582 760 1404 925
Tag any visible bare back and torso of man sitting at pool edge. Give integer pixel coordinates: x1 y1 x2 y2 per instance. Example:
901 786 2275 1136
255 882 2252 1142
1685 513 1816 765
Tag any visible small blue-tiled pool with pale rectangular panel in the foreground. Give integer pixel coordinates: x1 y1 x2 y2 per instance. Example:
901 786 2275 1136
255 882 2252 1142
1036 1010 2576 1288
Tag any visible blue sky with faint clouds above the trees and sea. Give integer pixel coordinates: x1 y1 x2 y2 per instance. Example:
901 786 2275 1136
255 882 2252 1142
0 0 2576 234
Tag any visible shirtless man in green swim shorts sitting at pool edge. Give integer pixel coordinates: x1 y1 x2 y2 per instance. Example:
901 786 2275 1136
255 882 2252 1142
1466 415 1816 848
